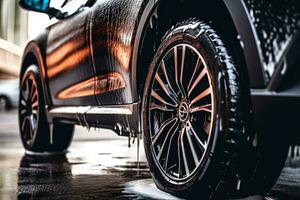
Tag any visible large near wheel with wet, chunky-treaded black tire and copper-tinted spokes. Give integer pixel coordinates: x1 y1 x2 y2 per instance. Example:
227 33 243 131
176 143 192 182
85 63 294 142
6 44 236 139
141 19 253 199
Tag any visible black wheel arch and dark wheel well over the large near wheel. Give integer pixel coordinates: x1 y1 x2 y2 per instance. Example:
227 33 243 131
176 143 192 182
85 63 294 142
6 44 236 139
132 0 264 99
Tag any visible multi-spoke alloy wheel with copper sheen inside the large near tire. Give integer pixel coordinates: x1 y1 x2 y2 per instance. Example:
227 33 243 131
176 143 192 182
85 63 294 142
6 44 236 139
149 44 215 182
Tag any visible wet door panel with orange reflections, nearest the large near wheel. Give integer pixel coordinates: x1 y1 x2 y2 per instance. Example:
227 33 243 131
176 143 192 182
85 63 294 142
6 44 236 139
90 0 148 106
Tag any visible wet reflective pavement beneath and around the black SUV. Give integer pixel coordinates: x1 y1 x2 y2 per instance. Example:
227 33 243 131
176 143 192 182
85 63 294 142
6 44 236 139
0 111 300 200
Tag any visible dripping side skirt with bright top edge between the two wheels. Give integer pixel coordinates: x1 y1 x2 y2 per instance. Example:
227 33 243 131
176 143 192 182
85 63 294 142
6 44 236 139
48 102 141 136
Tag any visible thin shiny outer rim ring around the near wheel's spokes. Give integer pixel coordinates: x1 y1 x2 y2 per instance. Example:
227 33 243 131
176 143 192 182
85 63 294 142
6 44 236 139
147 41 216 185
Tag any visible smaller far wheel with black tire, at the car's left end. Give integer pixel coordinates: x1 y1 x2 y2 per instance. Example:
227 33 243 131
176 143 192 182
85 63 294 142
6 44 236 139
18 65 74 153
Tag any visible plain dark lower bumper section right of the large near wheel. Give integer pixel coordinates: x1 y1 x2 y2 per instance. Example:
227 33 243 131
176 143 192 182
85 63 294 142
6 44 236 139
251 85 300 134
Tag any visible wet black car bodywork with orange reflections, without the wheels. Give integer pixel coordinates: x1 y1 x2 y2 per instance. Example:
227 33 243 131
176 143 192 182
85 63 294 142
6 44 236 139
21 0 300 198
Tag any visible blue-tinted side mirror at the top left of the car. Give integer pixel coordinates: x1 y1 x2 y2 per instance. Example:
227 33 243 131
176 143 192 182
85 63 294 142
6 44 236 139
19 0 50 13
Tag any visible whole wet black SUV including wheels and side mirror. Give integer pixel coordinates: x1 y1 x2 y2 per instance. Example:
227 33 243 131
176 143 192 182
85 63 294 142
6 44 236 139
19 0 300 199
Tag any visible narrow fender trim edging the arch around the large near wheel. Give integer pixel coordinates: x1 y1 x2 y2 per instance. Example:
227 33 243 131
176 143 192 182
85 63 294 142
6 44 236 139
131 0 266 103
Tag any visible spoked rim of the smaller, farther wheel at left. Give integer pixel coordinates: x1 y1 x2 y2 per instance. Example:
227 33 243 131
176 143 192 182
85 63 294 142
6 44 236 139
19 71 40 147
